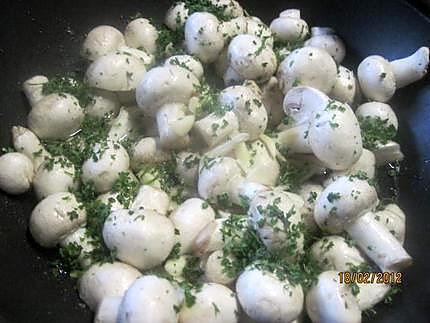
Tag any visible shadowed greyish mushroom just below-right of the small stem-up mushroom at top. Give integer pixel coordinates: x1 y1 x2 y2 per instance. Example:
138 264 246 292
305 27 345 64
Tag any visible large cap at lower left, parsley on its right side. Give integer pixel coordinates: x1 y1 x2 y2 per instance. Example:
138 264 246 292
29 192 87 248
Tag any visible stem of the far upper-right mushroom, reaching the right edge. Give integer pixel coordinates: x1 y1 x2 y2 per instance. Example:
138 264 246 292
391 47 429 88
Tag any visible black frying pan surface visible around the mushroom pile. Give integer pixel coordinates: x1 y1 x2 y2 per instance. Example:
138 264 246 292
0 0 430 323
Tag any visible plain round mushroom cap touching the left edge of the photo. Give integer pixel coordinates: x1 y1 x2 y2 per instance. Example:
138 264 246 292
0 153 34 194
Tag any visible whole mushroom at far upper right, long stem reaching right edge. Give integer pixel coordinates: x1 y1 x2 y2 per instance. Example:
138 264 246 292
358 47 429 102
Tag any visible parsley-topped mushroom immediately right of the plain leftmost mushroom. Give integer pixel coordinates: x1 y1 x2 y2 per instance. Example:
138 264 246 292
33 156 77 200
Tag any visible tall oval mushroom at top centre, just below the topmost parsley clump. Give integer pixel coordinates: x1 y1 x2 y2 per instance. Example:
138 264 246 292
185 12 224 64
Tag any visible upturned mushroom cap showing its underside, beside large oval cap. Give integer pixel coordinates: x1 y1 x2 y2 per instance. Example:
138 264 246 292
283 86 330 125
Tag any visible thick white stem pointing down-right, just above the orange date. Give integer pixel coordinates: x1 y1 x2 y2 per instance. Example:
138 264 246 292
345 212 412 271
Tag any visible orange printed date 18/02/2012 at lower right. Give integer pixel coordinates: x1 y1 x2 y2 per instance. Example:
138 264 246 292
339 271 403 284
